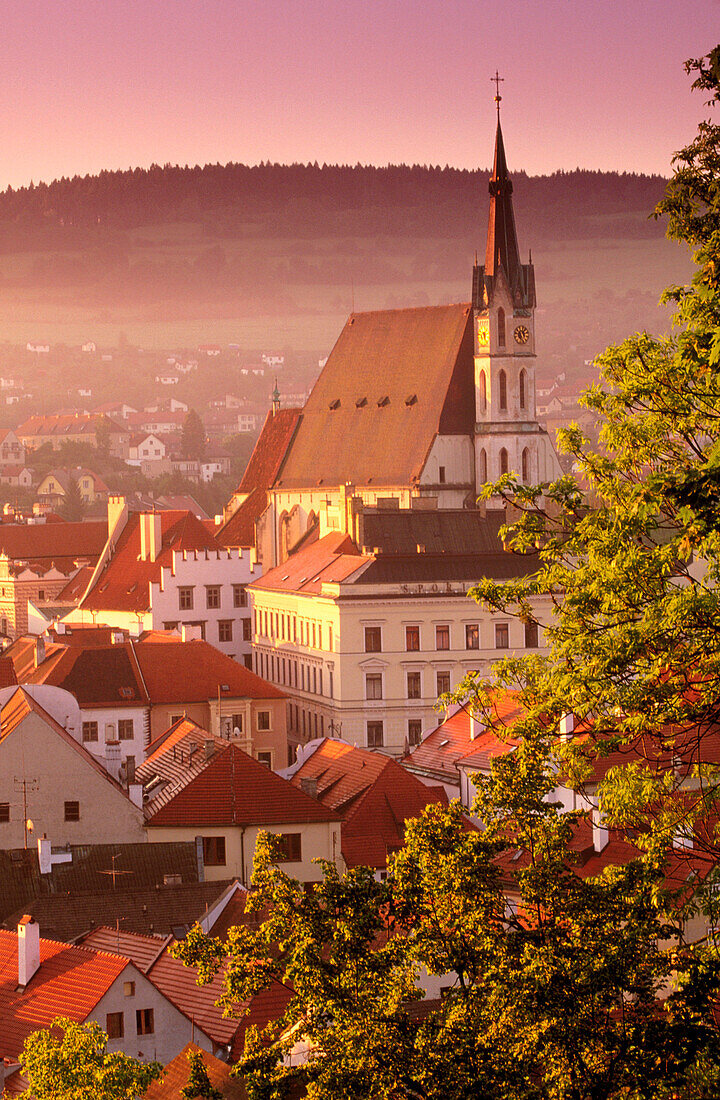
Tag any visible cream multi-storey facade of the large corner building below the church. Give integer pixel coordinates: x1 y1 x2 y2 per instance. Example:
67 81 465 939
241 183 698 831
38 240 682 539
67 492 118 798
248 582 551 756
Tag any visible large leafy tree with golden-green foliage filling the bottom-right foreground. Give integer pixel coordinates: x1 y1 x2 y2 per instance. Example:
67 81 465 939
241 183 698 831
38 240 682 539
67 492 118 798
176 746 720 1100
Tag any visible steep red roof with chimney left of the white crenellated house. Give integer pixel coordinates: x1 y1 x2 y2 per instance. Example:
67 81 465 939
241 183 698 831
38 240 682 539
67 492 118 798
80 510 218 612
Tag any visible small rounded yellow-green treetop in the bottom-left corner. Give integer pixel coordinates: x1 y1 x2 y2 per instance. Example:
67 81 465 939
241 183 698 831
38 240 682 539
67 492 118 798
20 1016 163 1100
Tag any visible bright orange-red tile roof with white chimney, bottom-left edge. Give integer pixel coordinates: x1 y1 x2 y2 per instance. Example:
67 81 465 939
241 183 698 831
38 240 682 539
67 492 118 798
0 930 130 1058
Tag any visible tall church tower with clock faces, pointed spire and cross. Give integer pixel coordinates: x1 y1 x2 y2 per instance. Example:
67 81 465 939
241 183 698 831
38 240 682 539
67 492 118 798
473 88 561 488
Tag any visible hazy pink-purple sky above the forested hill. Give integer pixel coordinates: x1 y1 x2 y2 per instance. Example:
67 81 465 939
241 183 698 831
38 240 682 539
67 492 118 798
0 0 720 187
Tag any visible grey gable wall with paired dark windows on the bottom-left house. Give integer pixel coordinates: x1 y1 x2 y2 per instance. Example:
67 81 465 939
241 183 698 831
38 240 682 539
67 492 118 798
87 963 213 1065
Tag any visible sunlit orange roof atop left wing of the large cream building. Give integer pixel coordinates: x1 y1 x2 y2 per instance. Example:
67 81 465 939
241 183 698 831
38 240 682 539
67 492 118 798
248 531 375 595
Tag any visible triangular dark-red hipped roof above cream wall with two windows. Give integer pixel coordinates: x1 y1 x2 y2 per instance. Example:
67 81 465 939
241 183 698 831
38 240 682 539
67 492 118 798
144 744 339 828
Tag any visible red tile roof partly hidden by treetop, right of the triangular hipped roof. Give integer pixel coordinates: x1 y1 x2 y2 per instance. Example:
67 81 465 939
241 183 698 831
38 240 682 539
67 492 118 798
291 739 447 867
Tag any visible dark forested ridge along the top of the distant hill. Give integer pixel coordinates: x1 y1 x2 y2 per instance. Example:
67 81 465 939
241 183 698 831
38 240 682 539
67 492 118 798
0 163 665 252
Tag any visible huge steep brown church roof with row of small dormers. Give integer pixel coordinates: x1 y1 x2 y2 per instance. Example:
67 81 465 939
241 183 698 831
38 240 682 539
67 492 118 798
274 303 475 490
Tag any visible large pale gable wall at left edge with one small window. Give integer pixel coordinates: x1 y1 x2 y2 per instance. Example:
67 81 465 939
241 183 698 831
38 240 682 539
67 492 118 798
0 712 146 848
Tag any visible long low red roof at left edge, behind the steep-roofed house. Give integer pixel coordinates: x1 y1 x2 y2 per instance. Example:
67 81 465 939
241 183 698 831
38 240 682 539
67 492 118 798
0 520 108 572
